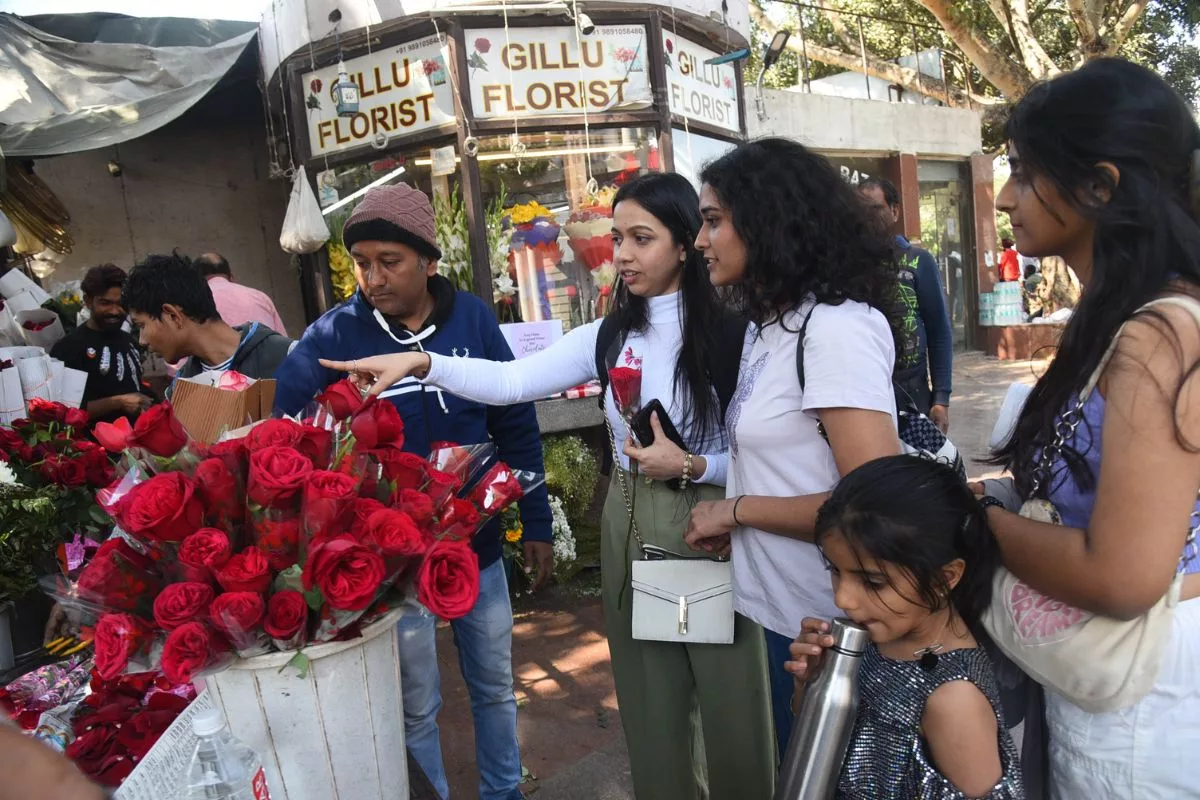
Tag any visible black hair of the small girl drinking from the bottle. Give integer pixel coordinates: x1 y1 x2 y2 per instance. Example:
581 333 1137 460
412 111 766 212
815 456 1001 637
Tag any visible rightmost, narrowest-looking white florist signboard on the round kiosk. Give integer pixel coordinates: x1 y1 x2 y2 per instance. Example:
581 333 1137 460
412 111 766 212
662 31 742 133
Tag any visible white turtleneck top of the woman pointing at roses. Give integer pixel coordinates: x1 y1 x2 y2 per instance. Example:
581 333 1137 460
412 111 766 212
424 291 728 486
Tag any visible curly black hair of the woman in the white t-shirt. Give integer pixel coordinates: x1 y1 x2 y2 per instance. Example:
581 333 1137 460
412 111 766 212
700 138 896 327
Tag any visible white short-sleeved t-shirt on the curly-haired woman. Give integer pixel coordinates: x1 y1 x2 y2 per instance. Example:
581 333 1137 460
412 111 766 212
725 302 895 637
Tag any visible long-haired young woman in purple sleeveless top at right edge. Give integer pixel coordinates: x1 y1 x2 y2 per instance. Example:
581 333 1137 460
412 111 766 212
988 59 1200 798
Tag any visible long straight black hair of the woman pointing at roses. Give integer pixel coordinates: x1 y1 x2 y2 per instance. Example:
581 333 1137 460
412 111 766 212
612 173 728 443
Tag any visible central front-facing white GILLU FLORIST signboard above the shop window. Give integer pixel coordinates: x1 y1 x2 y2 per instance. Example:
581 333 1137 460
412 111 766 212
467 25 653 118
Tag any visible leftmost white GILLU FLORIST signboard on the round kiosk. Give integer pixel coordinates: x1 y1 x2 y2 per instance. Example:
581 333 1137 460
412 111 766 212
304 36 455 156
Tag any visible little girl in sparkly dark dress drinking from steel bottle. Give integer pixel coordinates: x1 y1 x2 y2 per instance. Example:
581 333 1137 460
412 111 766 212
785 456 1025 800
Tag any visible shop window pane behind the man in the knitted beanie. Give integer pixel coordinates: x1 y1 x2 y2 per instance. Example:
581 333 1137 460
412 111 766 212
317 144 460 301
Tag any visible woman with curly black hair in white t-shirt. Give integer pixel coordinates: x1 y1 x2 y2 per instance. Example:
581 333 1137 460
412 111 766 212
688 139 900 752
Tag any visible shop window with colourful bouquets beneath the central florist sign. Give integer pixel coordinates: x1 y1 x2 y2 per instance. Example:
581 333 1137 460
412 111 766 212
478 128 660 331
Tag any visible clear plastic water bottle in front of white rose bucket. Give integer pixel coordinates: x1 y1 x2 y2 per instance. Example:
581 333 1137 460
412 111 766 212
187 709 271 800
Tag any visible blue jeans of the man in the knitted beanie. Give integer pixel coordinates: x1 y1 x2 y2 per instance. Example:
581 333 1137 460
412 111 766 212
400 560 521 800
